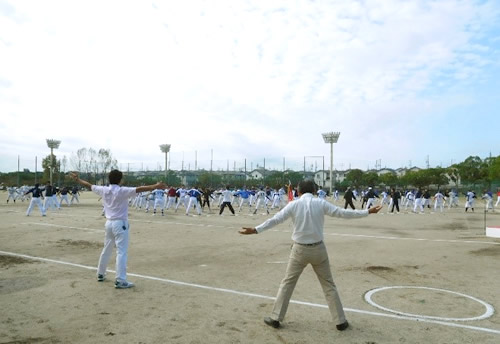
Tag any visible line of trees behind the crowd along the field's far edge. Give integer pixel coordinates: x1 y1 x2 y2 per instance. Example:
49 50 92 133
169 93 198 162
0 152 500 190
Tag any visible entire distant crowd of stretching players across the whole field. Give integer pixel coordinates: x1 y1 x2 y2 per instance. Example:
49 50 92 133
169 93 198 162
7 182 500 216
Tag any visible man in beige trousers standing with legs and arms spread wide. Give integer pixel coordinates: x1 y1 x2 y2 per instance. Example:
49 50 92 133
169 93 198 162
239 180 382 331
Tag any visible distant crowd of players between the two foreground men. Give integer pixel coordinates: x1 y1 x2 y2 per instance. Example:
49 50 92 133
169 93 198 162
130 185 296 216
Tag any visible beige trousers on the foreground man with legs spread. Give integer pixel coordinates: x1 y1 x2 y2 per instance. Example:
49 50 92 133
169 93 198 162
271 243 346 325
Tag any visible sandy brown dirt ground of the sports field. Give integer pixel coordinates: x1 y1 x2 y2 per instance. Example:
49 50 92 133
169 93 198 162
0 192 500 344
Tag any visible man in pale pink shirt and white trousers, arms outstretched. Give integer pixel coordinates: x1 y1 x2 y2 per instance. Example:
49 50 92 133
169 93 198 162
70 170 165 289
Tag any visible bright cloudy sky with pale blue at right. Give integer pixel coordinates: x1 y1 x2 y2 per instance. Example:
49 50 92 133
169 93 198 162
0 0 500 172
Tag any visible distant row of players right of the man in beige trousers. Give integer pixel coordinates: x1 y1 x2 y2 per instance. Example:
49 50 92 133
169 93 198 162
338 187 500 213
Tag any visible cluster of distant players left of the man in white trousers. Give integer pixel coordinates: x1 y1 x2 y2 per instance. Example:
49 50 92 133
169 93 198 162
7 182 80 216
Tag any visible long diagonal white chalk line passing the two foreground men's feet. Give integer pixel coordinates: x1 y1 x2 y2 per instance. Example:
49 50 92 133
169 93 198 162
0 251 500 335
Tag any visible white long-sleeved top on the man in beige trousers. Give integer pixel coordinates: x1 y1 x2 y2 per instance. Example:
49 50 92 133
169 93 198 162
255 193 368 244
